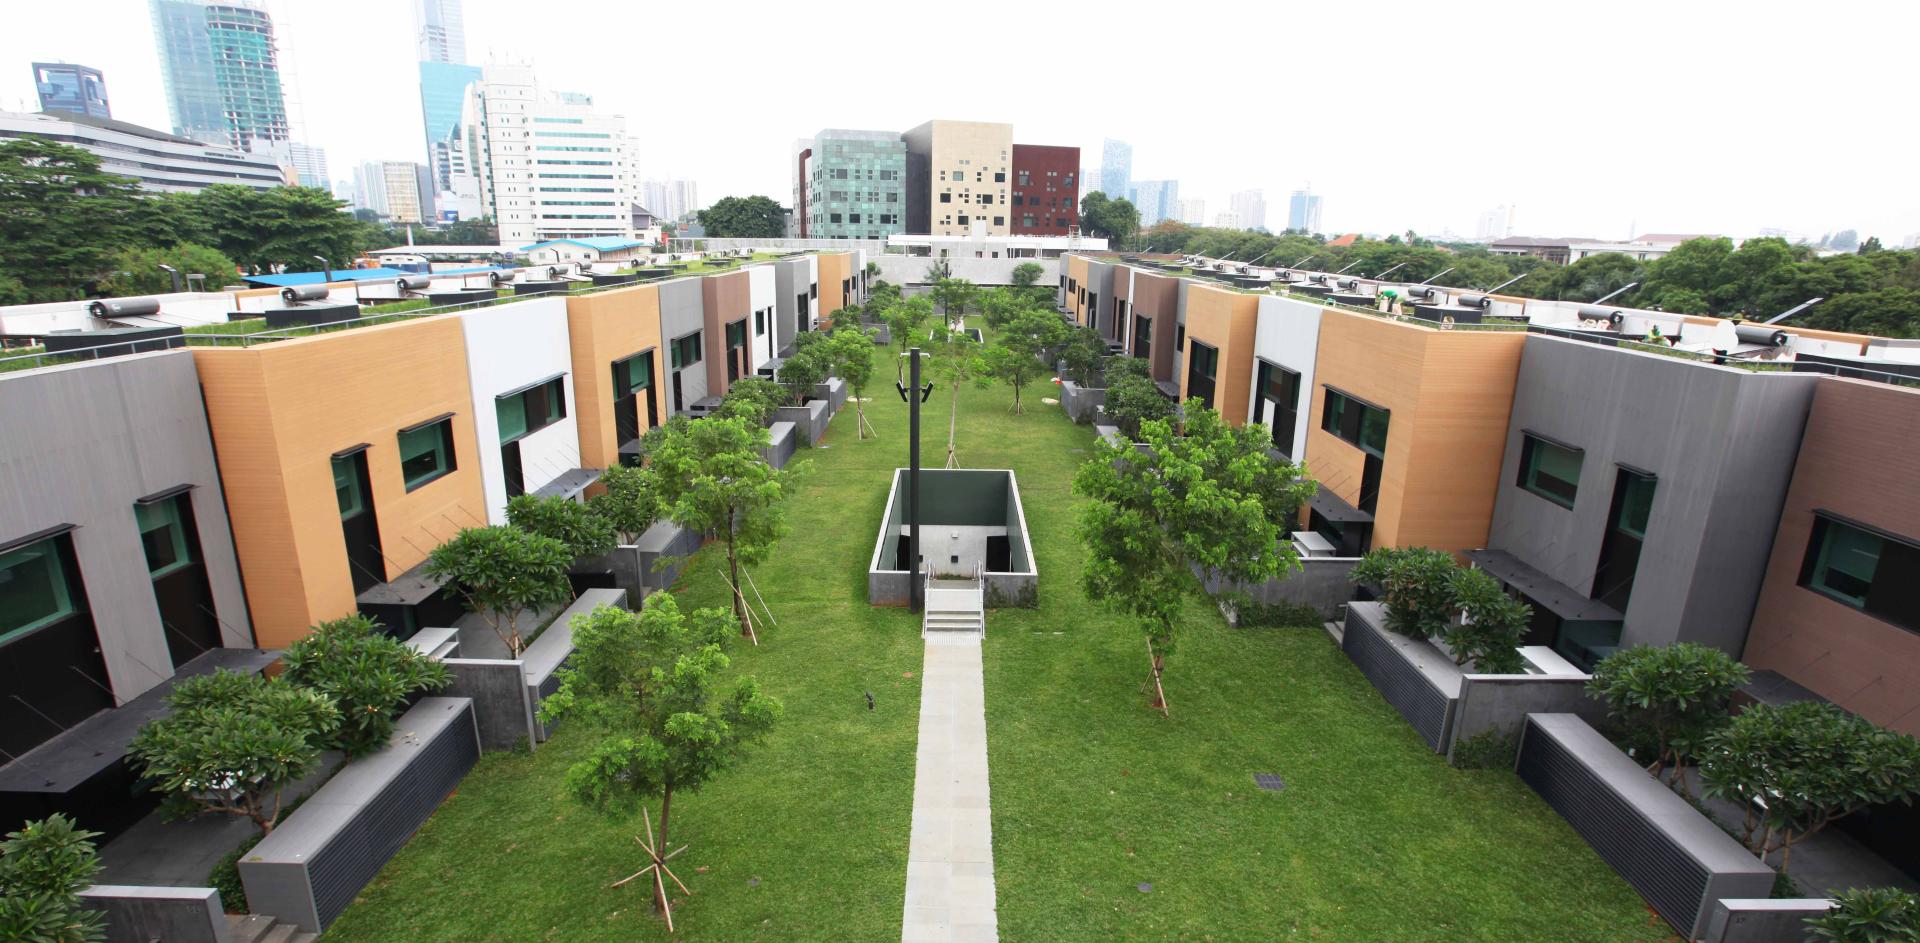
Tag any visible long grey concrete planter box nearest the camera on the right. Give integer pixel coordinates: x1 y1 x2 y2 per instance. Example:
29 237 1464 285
1515 714 1774 939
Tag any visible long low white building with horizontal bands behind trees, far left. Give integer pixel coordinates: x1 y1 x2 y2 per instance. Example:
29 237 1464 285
0 111 288 192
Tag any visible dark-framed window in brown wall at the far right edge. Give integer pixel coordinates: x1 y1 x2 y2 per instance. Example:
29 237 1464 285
1801 513 1920 632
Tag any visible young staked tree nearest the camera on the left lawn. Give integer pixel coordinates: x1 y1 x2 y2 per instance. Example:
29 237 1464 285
540 593 781 931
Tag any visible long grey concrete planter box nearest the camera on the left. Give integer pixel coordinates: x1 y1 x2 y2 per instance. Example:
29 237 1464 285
240 697 480 933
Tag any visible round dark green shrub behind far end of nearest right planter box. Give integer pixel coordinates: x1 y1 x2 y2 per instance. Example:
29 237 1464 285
1586 641 1753 795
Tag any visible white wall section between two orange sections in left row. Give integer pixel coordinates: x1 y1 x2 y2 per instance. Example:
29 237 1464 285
457 298 580 524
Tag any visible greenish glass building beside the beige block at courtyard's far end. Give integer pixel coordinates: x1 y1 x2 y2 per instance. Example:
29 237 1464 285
793 129 906 238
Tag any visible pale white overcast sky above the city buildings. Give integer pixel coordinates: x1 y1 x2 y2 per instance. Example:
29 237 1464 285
0 0 1920 244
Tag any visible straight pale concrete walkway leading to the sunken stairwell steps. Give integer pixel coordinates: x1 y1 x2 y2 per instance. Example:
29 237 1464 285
900 634 1000 943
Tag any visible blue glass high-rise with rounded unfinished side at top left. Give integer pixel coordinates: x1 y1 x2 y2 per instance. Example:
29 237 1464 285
150 0 288 152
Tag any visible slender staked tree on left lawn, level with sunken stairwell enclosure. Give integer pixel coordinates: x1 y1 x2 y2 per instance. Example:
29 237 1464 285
641 415 806 645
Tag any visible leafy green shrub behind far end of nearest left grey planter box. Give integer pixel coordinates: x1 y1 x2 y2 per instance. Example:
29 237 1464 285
280 615 453 757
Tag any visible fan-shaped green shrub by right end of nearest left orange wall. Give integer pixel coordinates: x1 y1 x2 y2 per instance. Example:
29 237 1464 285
426 526 574 659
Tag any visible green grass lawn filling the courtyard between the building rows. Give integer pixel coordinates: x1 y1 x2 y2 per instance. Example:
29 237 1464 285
326 328 1674 941
